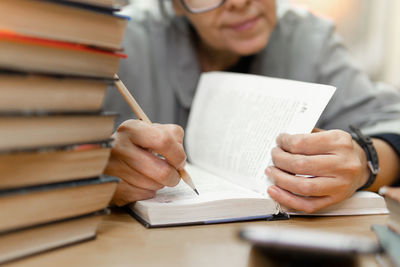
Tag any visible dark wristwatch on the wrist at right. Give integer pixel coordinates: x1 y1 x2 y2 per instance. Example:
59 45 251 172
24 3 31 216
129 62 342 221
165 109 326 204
349 125 379 191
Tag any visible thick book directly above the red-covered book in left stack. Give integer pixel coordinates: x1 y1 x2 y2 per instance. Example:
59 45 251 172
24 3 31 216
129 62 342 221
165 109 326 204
0 0 128 50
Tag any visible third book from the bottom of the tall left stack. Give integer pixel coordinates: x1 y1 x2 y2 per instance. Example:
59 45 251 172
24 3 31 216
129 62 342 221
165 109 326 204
0 140 111 190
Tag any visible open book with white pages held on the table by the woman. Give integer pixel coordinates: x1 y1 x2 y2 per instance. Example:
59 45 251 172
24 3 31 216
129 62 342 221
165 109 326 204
129 72 387 227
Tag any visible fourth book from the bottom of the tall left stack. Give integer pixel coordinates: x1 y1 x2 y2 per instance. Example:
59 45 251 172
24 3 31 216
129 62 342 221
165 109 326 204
0 113 115 151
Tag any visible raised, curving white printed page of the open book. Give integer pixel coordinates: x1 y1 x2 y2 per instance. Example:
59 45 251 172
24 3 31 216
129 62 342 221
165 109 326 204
185 72 335 194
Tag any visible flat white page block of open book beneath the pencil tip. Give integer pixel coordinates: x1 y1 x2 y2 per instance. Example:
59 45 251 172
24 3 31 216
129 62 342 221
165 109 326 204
133 164 275 226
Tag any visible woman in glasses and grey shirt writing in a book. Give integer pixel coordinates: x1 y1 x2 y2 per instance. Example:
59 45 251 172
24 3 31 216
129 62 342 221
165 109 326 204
106 0 400 213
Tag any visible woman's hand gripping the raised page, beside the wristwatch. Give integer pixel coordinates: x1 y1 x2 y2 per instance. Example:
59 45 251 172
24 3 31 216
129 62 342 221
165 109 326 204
265 130 369 213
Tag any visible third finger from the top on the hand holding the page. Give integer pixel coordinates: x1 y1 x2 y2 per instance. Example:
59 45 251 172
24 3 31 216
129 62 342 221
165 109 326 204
265 167 344 197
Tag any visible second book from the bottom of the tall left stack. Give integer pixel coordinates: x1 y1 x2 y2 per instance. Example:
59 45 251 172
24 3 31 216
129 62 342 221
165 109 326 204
0 177 119 232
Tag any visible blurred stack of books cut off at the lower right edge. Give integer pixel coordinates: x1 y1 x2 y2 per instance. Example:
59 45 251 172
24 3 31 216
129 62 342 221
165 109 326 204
372 187 400 266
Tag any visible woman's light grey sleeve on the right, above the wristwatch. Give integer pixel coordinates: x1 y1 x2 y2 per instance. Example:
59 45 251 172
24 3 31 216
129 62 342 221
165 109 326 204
317 26 400 138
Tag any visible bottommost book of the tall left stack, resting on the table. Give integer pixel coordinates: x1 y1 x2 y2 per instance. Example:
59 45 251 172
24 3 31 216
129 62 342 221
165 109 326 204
0 209 108 264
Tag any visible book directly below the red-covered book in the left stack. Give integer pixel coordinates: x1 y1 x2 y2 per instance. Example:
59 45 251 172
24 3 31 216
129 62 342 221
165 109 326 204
0 72 113 112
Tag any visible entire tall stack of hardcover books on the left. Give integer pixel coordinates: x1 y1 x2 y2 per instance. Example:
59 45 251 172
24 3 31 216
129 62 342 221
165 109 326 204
0 0 127 264
